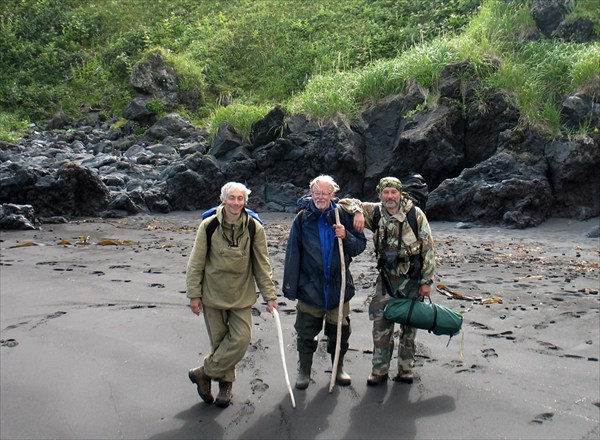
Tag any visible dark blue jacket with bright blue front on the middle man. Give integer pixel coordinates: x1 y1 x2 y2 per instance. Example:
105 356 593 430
283 197 367 310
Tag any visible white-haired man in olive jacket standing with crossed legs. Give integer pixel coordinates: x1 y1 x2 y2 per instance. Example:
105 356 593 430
186 182 278 407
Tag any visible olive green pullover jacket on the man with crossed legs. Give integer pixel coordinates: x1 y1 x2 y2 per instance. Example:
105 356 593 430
186 206 277 309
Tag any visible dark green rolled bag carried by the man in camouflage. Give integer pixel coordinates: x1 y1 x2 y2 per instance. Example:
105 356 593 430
383 297 463 336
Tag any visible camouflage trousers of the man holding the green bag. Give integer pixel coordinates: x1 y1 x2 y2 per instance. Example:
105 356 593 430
369 276 419 375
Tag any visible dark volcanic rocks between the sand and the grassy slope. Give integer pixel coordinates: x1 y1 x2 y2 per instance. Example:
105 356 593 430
0 56 600 228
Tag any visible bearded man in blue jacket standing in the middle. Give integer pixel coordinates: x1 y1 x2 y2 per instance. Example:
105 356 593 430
283 175 367 389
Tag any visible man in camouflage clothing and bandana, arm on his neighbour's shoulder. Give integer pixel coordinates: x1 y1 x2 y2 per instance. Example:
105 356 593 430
340 177 435 385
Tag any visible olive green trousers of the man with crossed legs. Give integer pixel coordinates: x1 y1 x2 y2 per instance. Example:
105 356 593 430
203 306 252 382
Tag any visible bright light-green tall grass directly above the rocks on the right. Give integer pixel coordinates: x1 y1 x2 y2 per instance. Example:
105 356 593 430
288 0 600 135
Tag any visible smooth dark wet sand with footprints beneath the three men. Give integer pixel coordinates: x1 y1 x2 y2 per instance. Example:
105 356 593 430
0 212 600 439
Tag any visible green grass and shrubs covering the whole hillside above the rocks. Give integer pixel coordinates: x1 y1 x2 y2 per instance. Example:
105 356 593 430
0 0 600 136
